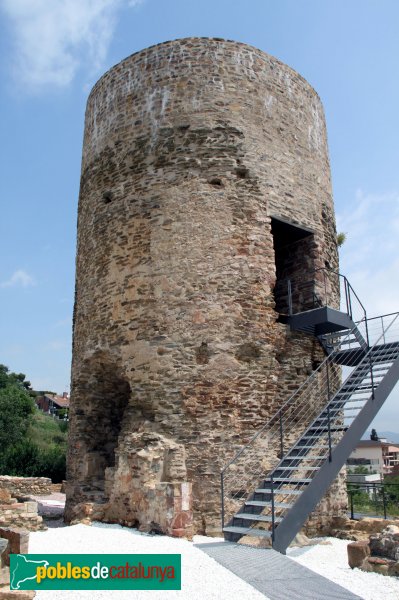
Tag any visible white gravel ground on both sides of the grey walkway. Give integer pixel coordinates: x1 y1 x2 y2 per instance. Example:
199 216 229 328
29 523 399 600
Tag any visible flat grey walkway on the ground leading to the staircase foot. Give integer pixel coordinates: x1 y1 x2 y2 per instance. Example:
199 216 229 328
195 542 362 600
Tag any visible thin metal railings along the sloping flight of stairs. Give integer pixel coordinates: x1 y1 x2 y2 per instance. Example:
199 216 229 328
221 313 399 532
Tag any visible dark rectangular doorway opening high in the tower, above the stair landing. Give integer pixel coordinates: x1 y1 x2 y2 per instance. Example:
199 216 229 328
271 217 315 315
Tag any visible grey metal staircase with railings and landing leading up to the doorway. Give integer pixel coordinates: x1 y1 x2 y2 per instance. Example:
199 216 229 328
221 270 399 554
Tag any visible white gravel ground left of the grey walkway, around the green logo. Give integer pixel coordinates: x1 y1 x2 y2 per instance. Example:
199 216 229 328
29 523 265 600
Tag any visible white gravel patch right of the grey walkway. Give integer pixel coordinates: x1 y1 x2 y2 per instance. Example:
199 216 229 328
287 538 399 600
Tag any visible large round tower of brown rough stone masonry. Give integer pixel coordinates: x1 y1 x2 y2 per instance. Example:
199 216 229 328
66 38 341 535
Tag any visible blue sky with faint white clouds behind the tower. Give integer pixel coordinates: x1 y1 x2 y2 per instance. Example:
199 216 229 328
0 0 399 431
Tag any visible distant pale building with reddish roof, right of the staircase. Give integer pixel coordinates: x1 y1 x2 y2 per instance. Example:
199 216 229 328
346 438 399 477
